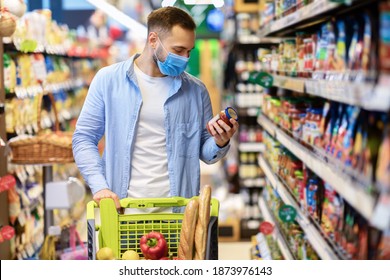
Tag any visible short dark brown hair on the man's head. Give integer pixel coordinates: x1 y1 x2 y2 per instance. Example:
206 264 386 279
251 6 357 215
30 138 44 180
147 7 196 36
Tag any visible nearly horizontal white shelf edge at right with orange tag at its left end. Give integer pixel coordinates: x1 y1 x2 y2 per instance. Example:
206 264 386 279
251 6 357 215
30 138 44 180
274 75 390 112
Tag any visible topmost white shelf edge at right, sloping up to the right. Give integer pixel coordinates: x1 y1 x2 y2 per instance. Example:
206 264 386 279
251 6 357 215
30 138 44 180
260 0 340 37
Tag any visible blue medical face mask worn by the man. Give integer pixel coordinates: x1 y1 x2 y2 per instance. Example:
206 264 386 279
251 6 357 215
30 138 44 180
154 38 189 76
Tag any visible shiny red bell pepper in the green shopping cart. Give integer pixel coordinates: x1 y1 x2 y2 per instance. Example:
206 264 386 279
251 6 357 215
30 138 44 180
140 231 168 260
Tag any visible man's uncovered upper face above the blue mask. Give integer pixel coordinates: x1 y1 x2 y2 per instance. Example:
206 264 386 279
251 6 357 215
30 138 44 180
154 25 195 62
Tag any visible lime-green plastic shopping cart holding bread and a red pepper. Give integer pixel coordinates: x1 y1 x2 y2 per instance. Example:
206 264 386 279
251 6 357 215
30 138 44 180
87 197 219 260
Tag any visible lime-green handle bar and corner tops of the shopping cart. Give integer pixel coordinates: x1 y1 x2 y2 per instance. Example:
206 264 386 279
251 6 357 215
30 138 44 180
87 196 219 220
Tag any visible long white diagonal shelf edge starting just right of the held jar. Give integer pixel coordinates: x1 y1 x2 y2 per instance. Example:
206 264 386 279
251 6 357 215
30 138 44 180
258 115 376 221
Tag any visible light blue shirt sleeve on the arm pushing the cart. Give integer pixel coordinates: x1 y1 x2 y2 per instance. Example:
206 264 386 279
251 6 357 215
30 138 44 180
72 70 109 194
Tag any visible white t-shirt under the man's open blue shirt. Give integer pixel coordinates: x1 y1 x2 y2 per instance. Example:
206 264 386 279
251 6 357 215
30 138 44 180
126 63 173 213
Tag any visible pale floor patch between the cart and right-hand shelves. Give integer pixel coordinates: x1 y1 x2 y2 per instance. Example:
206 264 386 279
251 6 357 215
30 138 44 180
218 242 251 260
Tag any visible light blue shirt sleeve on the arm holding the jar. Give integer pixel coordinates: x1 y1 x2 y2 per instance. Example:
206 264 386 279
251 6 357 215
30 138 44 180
200 82 230 164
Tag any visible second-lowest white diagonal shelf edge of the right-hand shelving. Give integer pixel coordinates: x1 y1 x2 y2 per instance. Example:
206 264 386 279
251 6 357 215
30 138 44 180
259 155 346 260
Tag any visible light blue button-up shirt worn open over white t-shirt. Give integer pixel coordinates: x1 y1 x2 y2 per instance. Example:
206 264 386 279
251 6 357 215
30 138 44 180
73 55 230 203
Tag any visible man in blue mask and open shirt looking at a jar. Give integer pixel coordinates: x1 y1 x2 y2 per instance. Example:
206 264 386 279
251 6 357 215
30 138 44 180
73 7 238 212
